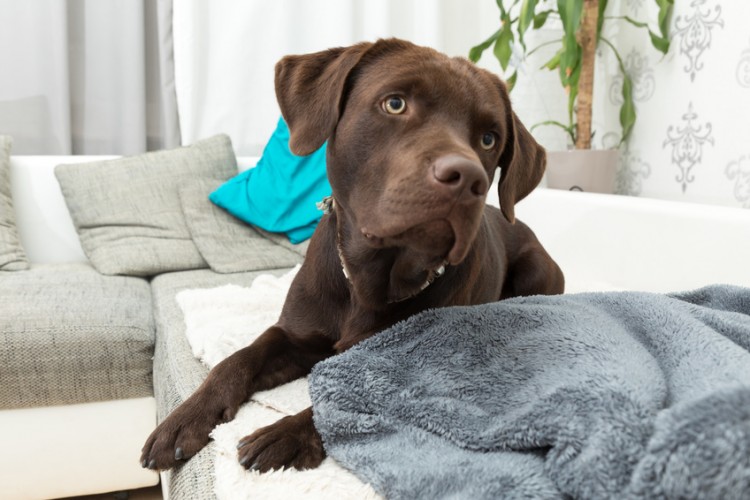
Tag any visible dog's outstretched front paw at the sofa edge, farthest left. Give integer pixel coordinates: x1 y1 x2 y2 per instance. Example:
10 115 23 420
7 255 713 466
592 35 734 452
141 399 234 470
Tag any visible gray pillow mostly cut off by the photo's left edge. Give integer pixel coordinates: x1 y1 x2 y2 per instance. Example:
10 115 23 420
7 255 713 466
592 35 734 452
0 135 29 271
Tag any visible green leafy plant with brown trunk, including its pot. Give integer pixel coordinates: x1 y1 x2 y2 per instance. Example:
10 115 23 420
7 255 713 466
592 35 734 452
469 0 674 192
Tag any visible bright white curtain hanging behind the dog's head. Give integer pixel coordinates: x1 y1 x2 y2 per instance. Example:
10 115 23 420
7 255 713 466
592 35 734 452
173 0 497 155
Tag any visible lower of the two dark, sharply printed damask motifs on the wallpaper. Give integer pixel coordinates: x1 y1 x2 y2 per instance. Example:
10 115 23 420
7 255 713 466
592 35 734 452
662 102 714 193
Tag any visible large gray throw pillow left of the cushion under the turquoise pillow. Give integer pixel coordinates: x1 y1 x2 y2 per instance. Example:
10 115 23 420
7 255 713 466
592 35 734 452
55 135 237 276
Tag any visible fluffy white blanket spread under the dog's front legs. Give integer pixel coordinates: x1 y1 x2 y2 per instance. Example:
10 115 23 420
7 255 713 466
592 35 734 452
177 266 379 500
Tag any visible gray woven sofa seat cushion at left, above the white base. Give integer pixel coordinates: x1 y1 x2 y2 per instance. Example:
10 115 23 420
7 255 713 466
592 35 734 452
0 264 154 409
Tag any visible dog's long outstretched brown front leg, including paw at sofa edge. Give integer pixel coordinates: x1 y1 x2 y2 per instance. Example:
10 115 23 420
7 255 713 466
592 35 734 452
141 326 333 469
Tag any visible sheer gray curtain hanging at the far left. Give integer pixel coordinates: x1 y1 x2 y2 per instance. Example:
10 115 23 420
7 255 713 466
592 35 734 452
0 0 179 154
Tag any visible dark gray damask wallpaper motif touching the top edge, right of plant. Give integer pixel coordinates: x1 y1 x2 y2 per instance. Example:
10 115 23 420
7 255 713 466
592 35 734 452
673 0 724 81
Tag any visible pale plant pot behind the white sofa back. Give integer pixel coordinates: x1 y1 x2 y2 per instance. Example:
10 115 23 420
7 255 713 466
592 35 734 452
546 149 619 194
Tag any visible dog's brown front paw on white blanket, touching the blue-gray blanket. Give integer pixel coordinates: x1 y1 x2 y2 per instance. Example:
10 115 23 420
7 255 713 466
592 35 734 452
237 408 326 472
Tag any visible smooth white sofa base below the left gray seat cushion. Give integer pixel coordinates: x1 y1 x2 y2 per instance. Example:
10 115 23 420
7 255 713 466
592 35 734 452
0 397 159 500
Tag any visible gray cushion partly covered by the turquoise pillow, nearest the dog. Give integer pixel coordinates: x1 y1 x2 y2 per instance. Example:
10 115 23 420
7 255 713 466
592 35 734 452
180 179 300 273
